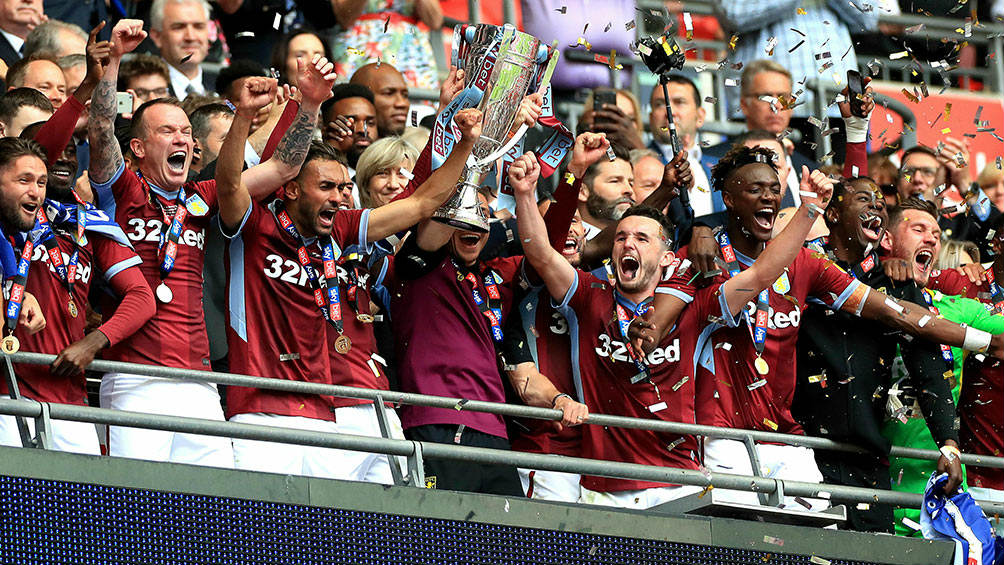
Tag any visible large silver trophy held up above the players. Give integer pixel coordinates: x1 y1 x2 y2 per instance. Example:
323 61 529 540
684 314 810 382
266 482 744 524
433 24 548 232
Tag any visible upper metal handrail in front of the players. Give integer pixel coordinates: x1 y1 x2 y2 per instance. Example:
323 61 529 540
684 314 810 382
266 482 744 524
10 351 1004 469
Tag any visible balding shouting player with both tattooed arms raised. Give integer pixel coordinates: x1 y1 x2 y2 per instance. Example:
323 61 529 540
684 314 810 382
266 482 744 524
88 19 334 467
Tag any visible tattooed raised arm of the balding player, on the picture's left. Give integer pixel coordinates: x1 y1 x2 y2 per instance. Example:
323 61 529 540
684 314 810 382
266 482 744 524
87 20 147 185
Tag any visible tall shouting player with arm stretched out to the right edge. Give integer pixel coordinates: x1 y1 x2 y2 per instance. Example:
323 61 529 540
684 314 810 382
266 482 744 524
639 148 1004 506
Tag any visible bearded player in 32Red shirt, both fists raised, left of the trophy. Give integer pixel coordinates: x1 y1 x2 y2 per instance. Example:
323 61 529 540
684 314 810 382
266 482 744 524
216 77 481 484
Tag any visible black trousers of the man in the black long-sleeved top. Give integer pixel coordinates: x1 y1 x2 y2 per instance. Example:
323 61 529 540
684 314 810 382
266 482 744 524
815 450 896 534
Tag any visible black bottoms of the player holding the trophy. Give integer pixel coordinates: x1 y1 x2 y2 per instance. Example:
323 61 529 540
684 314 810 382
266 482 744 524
405 423 524 497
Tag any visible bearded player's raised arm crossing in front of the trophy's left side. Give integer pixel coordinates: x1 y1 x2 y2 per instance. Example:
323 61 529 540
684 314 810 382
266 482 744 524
366 108 483 241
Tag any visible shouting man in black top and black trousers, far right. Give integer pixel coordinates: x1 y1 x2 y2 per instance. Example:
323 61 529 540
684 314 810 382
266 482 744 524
792 178 962 533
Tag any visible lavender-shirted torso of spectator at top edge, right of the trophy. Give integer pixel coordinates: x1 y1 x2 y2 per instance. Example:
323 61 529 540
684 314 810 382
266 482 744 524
521 0 641 96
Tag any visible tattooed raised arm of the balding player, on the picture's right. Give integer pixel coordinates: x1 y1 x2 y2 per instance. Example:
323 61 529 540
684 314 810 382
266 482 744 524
241 55 335 199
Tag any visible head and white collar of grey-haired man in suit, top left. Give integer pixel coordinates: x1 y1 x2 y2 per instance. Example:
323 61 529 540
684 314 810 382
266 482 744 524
150 0 216 100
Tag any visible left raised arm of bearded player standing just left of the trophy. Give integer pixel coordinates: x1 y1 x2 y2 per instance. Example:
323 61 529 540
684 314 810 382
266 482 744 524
216 76 278 234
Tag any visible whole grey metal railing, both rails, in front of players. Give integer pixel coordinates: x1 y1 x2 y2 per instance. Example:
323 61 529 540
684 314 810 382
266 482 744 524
0 352 1004 515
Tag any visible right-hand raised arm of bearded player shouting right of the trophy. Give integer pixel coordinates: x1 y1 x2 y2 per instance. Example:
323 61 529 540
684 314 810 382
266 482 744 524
722 166 833 316
